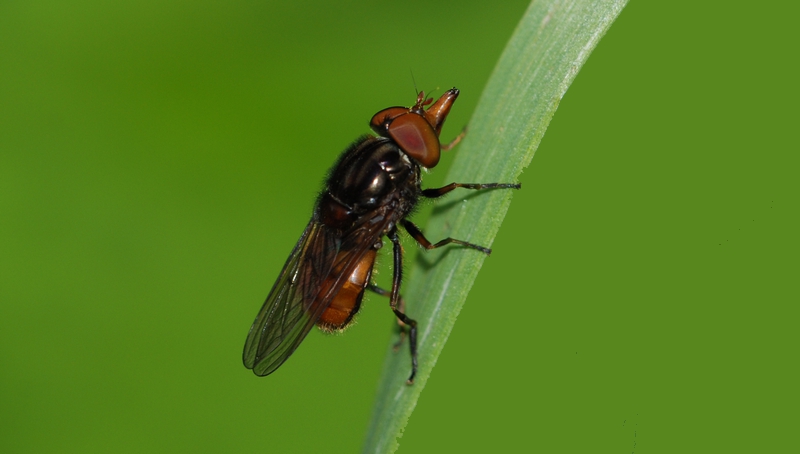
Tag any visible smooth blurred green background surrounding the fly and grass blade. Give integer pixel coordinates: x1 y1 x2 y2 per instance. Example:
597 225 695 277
0 0 800 453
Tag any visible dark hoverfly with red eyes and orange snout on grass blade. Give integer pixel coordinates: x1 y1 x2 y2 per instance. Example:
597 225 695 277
243 88 520 384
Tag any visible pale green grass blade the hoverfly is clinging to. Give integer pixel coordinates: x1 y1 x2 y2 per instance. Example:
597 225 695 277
364 0 627 453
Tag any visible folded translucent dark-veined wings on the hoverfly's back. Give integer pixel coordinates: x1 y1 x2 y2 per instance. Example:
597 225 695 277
242 216 388 376
